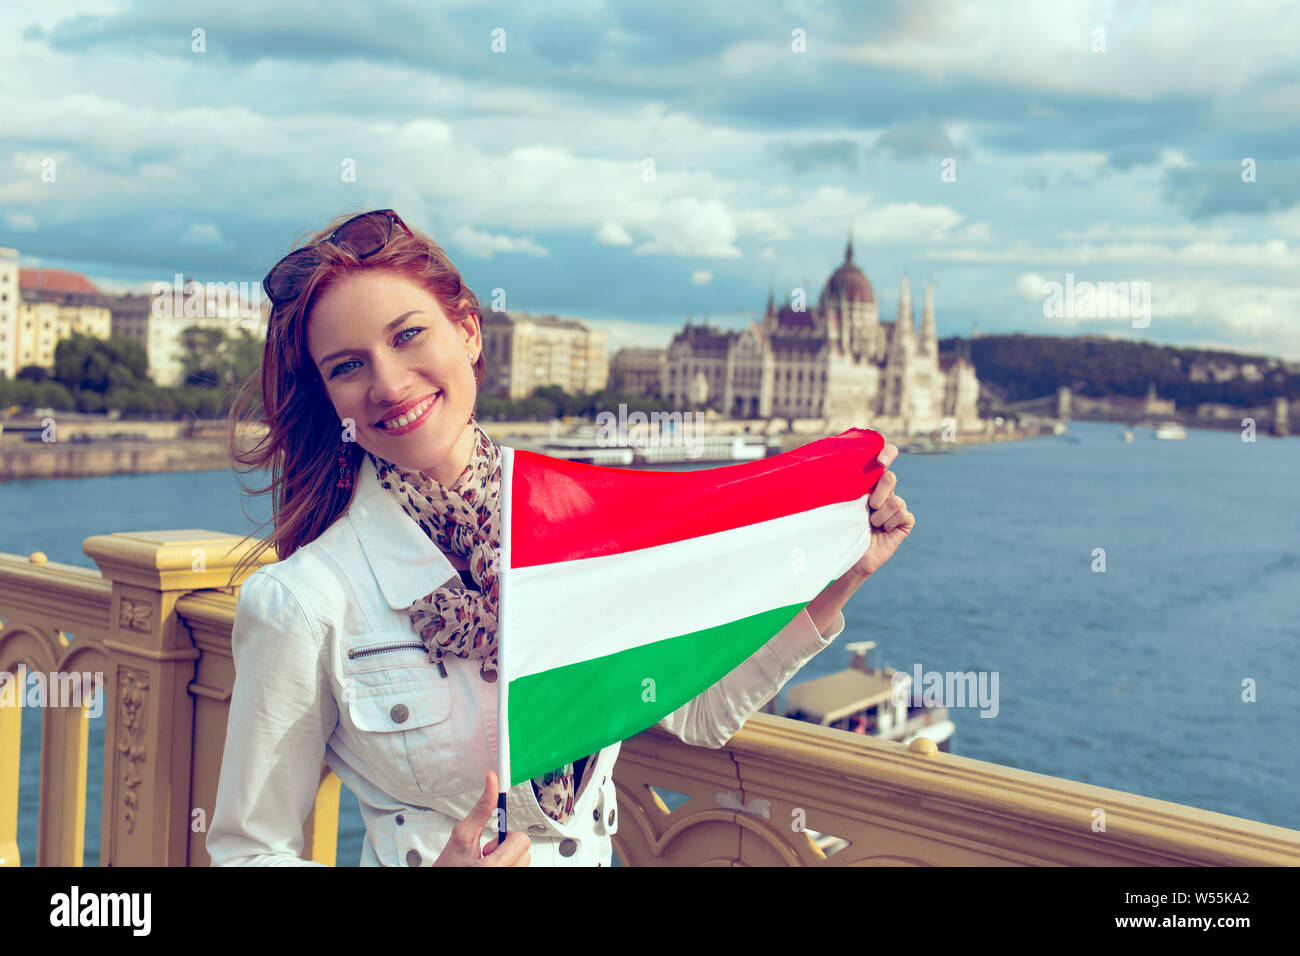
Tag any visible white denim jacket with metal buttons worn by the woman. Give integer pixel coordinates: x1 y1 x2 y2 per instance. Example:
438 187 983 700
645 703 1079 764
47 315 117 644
207 455 844 866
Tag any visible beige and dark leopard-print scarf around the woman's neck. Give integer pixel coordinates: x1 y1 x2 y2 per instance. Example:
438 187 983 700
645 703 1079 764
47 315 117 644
371 415 587 822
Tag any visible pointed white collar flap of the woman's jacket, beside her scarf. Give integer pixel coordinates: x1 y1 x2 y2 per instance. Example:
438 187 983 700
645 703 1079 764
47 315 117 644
347 454 460 610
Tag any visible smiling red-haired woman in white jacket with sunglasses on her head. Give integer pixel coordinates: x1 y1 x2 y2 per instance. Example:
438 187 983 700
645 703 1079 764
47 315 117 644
207 209 915 866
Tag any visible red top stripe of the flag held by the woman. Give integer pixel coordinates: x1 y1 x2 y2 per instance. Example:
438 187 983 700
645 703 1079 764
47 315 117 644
510 428 885 567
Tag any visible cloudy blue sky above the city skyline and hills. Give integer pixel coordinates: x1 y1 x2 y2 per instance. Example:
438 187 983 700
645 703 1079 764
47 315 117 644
0 0 1300 359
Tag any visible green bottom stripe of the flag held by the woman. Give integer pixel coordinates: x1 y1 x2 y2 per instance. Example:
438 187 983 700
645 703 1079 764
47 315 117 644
508 582 832 786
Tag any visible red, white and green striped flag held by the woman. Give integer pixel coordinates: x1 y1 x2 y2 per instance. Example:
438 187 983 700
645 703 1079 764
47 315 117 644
497 428 884 786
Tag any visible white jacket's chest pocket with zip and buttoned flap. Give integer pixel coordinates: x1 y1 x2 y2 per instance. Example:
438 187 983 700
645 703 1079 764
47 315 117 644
341 645 464 797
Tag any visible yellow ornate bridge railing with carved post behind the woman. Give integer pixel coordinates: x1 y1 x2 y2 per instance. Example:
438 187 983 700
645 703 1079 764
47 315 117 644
0 529 1300 866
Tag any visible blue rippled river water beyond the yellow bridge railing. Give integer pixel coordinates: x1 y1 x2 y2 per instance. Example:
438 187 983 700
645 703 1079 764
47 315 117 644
0 423 1300 865
